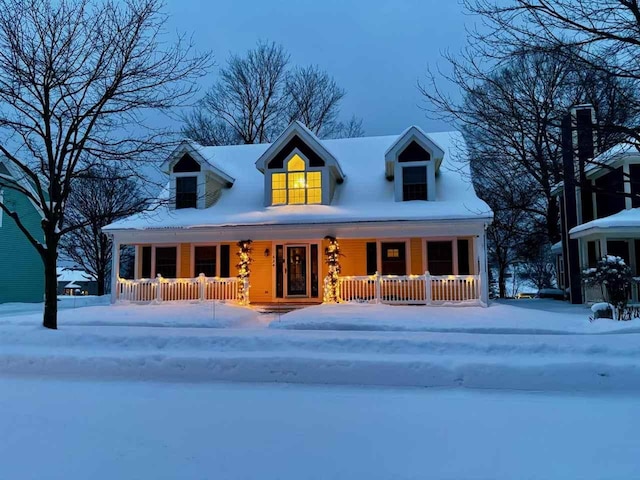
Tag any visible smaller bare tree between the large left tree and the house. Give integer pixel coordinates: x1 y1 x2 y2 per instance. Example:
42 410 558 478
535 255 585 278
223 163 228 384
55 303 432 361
60 166 148 295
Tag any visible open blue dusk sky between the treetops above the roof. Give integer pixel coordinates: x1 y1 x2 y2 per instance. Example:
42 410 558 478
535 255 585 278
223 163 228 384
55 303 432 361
167 0 470 135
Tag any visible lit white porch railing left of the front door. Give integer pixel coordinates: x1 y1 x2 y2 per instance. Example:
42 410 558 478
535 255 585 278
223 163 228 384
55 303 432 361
116 274 248 302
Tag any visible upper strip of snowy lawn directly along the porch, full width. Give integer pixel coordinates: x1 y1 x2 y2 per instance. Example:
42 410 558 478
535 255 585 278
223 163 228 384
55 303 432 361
0 297 640 335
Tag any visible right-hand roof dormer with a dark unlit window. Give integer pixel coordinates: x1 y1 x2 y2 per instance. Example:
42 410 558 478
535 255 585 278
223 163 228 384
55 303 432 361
384 126 444 202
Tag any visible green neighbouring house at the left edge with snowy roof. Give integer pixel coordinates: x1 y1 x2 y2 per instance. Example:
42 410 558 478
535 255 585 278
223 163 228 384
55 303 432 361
0 157 44 303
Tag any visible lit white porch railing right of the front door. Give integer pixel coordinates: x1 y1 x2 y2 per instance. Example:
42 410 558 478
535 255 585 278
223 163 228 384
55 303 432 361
336 272 481 305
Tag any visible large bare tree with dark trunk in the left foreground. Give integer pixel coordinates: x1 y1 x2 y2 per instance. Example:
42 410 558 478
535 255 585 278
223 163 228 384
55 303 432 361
0 0 209 328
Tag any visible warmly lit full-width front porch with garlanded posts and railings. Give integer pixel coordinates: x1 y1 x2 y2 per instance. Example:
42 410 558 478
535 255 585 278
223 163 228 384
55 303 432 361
112 223 487 305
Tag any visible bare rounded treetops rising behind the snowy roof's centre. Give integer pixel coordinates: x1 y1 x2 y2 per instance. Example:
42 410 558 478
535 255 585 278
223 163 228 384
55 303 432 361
183 42 362 145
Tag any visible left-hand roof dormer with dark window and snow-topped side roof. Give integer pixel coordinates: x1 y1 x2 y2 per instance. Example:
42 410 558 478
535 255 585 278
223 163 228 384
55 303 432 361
162 141 235 210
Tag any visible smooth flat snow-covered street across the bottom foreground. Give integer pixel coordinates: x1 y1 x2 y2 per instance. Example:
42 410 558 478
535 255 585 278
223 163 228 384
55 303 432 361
0 377 640 480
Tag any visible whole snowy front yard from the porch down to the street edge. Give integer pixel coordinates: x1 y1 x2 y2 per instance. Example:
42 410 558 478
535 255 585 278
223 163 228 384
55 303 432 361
0 301 640 391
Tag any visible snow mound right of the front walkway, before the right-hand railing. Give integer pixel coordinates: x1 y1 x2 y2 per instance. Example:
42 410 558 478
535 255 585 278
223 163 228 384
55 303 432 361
270 299 640 334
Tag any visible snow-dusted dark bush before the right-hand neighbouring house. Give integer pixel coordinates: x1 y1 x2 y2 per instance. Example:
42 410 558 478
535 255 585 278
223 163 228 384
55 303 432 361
582 255 636 320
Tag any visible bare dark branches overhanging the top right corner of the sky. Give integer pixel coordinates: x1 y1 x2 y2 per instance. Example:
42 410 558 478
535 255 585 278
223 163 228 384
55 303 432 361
464 0 640 142
